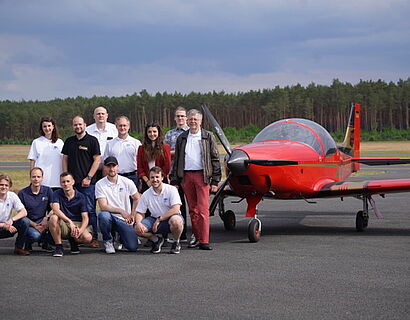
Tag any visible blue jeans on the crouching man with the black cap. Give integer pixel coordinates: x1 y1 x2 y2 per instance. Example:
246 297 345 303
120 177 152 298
98 211 138 251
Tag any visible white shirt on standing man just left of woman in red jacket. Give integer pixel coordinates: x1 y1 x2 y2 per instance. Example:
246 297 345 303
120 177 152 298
103 136 141 173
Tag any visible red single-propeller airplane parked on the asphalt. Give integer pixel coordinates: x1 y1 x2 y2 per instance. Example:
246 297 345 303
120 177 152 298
202 104 410 242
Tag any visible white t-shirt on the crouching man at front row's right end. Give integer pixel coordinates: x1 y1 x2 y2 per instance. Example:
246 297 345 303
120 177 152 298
137 183 182 218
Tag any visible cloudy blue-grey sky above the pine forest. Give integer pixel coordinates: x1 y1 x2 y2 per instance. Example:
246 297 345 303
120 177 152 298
0 0 410 101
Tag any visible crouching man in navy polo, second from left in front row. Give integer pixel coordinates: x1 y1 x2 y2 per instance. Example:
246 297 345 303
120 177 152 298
18 167 53 251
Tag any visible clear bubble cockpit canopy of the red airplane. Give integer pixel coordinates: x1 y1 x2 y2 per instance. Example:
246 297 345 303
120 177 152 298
253 118 337 155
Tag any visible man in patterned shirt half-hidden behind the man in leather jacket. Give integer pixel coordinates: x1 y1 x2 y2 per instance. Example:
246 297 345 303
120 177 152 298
164 107 189 241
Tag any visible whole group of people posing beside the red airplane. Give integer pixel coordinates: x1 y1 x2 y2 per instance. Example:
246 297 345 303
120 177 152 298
0 106 221 257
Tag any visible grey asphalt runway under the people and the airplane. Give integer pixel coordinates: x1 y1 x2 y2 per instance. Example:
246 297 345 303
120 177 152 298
0 166 410 319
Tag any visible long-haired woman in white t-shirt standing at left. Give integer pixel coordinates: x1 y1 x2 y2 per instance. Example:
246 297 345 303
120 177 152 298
27 117 64 188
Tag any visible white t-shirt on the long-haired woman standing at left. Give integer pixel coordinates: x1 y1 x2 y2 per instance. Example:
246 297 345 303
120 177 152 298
27 136 64 188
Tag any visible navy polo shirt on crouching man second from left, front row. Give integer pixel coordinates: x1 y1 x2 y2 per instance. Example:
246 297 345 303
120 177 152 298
18 186 53 223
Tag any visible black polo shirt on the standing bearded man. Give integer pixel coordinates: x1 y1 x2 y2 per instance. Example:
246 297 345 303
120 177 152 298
61 133 100 184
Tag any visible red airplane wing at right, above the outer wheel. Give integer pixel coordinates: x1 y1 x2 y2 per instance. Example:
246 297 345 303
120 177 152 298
317 179 410 198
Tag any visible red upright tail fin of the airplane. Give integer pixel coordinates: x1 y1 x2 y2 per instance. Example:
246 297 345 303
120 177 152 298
340 103 360 171
